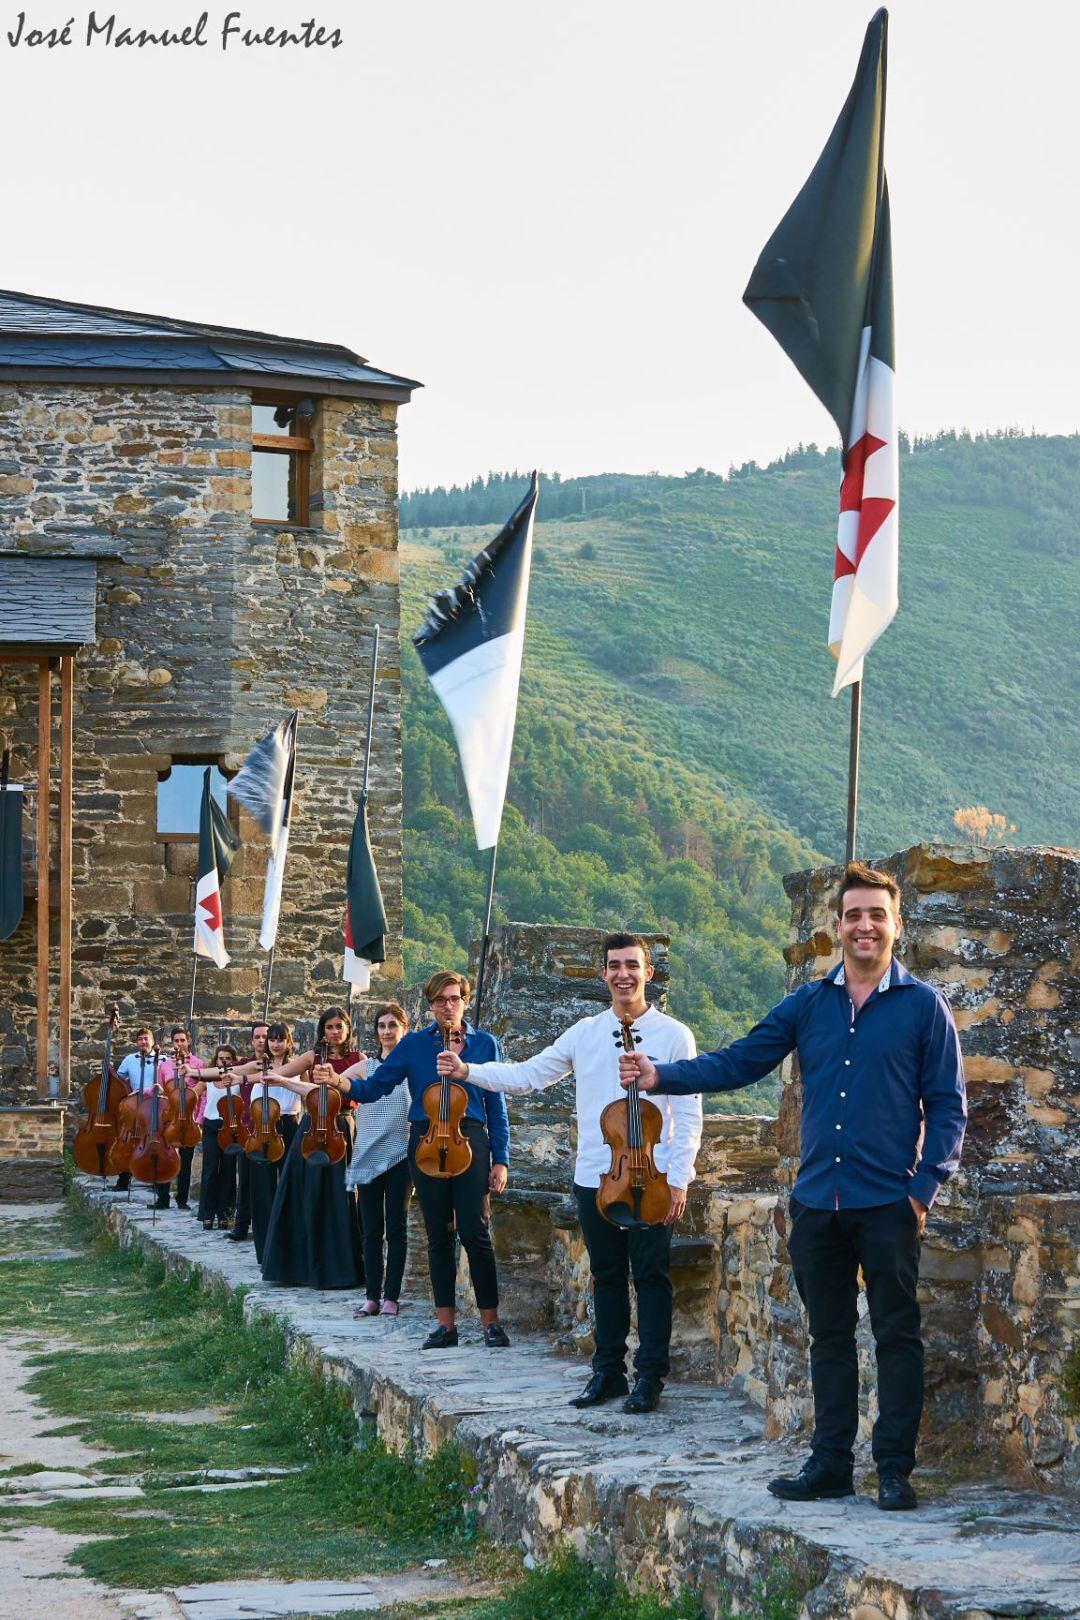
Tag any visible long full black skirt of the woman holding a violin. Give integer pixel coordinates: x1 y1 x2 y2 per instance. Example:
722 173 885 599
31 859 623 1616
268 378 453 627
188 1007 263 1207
262 1110 364 1288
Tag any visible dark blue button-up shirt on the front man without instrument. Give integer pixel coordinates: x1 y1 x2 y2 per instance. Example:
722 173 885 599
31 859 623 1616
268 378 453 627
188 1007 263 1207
656 962 967 1210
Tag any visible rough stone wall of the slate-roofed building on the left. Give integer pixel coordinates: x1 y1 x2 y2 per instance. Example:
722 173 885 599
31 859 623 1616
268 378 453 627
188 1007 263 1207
0 384 402 1090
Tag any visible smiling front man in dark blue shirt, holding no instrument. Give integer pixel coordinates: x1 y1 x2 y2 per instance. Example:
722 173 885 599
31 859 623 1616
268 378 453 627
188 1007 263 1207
622 862 967 1510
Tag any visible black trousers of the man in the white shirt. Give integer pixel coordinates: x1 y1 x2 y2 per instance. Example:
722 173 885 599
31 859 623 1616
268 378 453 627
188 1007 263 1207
573 1181 672 1379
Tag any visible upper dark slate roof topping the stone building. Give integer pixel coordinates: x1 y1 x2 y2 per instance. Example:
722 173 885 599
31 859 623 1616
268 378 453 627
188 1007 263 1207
0 292 421 400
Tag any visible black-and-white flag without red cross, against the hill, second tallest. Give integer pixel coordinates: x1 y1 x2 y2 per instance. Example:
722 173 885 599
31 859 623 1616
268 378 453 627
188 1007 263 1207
413 473 539 849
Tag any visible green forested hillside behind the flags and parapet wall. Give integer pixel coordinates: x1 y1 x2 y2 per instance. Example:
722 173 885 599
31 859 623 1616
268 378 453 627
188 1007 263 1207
402 434 1080 1075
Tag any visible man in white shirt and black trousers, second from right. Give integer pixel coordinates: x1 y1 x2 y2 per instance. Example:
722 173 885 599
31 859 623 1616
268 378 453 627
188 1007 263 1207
437 933 701 1413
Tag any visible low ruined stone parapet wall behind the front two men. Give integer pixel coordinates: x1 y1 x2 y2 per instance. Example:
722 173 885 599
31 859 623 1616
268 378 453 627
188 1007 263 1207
486 846 1080 1477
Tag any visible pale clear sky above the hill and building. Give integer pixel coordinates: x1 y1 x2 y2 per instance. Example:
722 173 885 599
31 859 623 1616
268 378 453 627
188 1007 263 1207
0 0 1080 489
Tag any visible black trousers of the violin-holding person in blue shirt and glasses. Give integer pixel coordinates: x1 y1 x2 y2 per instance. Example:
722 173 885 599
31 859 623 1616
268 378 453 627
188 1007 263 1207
408 1119 499 1311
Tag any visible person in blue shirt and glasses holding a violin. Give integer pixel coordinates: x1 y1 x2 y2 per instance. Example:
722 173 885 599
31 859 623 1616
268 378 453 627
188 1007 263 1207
327 972 510 1349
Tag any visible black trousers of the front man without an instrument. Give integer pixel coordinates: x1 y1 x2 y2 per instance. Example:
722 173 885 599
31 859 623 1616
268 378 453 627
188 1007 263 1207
787 1199 923 1474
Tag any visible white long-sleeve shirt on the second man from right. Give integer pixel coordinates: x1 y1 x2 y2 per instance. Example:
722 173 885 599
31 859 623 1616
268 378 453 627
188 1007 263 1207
468 1008 701 1187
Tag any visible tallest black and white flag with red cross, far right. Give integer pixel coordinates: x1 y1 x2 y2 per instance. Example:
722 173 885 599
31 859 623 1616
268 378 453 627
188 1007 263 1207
743 8 900 697
